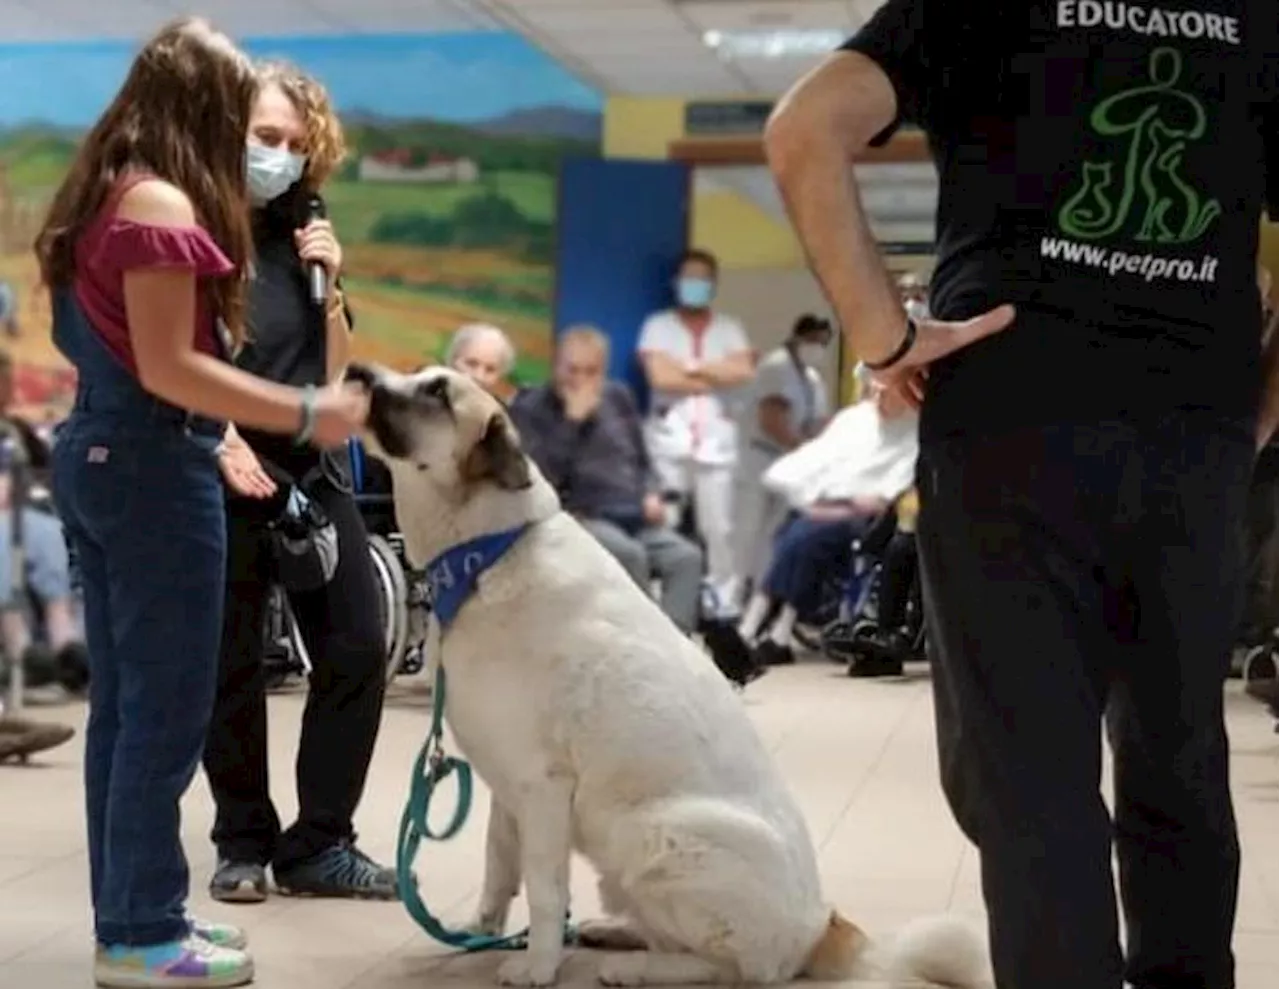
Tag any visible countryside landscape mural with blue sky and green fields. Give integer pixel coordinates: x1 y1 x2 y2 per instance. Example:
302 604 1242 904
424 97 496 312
0 32 603 415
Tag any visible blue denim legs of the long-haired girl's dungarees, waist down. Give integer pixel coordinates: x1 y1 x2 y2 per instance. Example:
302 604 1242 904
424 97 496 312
52 403 227 945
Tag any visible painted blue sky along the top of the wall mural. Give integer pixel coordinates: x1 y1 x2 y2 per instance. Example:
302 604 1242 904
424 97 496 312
0 32 602 127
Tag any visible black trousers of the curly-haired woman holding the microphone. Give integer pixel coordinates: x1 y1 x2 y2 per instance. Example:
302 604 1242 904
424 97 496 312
205 481 387 867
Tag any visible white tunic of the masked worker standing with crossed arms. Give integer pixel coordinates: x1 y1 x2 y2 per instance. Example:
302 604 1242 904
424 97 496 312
636 310 751 467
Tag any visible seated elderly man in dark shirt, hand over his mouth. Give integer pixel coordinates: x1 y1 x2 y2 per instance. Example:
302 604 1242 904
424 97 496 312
511 326 703 632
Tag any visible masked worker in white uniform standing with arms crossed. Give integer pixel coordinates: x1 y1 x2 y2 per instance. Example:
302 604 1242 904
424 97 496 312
636 251 755 618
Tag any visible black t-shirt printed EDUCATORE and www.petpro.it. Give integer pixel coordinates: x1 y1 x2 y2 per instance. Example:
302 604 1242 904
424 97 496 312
845 0 1280 439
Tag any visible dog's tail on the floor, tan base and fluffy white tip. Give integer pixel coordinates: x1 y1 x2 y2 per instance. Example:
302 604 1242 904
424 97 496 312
800 910 995 989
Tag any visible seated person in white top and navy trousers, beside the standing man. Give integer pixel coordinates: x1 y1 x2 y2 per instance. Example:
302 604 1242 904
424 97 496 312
739 373 919 665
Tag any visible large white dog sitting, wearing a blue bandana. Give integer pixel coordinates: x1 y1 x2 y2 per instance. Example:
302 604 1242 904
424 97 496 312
348 367 987 986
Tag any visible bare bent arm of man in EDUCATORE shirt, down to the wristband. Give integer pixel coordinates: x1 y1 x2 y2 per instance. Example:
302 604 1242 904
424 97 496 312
764 51 906 361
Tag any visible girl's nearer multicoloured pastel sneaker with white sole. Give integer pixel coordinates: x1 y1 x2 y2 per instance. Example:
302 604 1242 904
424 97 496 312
93 937 253 989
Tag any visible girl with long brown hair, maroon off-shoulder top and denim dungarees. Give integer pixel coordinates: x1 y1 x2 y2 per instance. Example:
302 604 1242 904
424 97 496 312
36 19 366 988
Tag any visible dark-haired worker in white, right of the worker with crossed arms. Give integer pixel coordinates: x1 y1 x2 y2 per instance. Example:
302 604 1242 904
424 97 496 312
737 313 831 587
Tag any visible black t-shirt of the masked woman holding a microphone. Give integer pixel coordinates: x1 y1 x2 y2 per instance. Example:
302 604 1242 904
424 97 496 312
236 193 351 476
